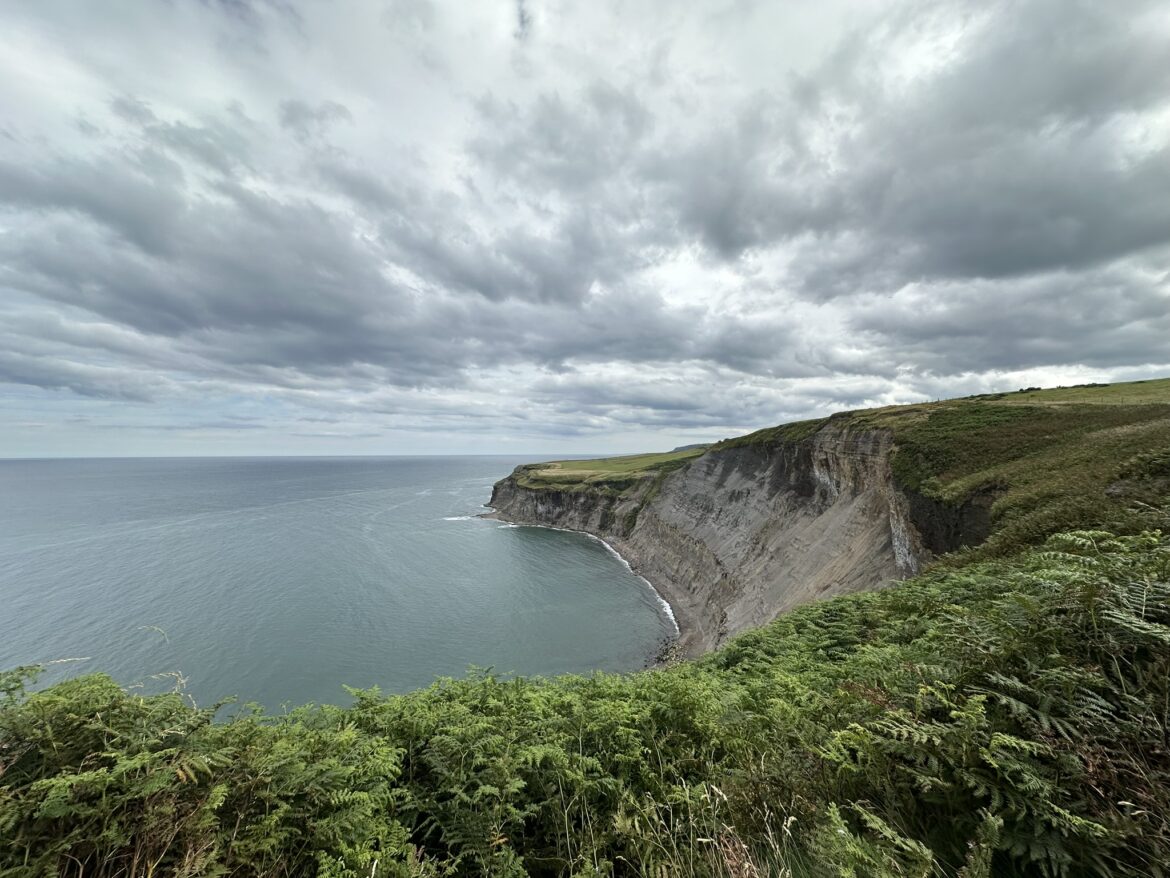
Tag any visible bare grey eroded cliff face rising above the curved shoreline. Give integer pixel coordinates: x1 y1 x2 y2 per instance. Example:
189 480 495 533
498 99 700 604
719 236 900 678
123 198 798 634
490 423 929 656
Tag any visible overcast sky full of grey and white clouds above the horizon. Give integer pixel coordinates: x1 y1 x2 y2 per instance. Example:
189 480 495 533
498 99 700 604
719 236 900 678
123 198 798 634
0 0 1170 457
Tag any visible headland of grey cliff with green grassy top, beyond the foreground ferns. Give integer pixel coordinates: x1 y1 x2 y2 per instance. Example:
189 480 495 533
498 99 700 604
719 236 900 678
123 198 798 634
489 379 1170 657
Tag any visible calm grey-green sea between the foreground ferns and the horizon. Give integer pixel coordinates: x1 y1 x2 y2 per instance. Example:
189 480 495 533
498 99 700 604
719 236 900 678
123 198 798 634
0 457 674 711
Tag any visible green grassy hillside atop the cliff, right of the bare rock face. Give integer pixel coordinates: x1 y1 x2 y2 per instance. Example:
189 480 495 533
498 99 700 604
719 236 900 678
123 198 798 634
715 378 1170 556
